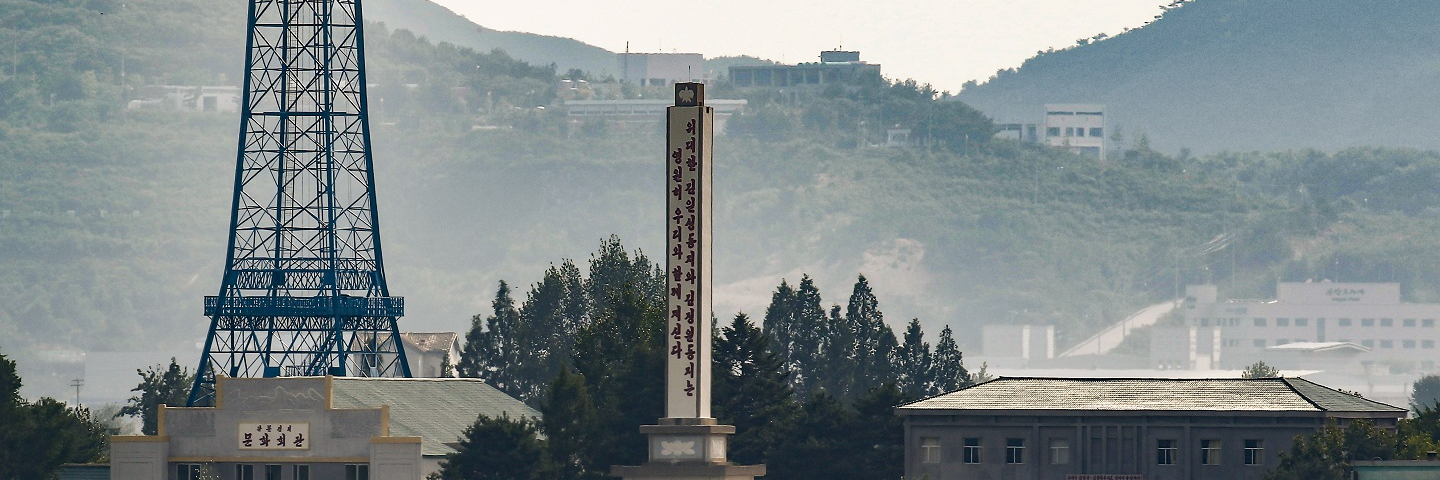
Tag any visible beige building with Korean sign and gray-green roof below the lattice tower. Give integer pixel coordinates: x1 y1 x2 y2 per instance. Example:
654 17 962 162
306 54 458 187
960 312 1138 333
109 376 540 480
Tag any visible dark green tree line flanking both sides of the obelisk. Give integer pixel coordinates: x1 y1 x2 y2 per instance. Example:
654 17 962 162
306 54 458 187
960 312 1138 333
441 236 971 479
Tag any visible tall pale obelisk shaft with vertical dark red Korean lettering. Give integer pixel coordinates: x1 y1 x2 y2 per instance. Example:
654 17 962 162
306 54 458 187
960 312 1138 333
665 84 714 418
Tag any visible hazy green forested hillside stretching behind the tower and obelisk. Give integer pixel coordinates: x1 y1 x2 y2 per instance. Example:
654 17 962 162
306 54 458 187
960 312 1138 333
0 0 1440 395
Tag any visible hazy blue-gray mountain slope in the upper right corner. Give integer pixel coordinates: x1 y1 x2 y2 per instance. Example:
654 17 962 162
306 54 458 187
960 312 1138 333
958 0 1440 153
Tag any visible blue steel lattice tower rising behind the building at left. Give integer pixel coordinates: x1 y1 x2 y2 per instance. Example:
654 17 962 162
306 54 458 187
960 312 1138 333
189 0 410 406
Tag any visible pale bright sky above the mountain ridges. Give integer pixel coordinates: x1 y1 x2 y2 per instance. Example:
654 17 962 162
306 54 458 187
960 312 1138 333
433 0 1168 91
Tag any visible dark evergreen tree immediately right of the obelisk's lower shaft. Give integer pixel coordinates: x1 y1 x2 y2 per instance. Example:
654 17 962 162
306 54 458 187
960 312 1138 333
713 313 799 464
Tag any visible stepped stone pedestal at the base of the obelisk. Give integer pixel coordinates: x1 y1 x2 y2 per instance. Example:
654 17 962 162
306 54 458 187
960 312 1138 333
611 418 765 480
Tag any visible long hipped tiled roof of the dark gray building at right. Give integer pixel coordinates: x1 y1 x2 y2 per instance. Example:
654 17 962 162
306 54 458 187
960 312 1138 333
900 378 1405 415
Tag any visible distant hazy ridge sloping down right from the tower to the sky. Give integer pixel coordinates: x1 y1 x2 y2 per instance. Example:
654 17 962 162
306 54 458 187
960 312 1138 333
364 0 616 76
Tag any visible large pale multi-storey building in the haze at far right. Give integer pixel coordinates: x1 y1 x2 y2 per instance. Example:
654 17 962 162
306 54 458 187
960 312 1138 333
1184 283 1440 370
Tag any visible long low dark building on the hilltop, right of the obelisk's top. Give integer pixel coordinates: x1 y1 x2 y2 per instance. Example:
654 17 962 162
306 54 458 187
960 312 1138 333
730 50 880 94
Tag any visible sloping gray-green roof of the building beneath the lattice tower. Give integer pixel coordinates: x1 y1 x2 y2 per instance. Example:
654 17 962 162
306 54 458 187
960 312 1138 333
330 378 540 455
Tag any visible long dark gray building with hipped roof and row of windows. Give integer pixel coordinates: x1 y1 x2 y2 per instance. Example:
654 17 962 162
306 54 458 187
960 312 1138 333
897 378 1407 480
